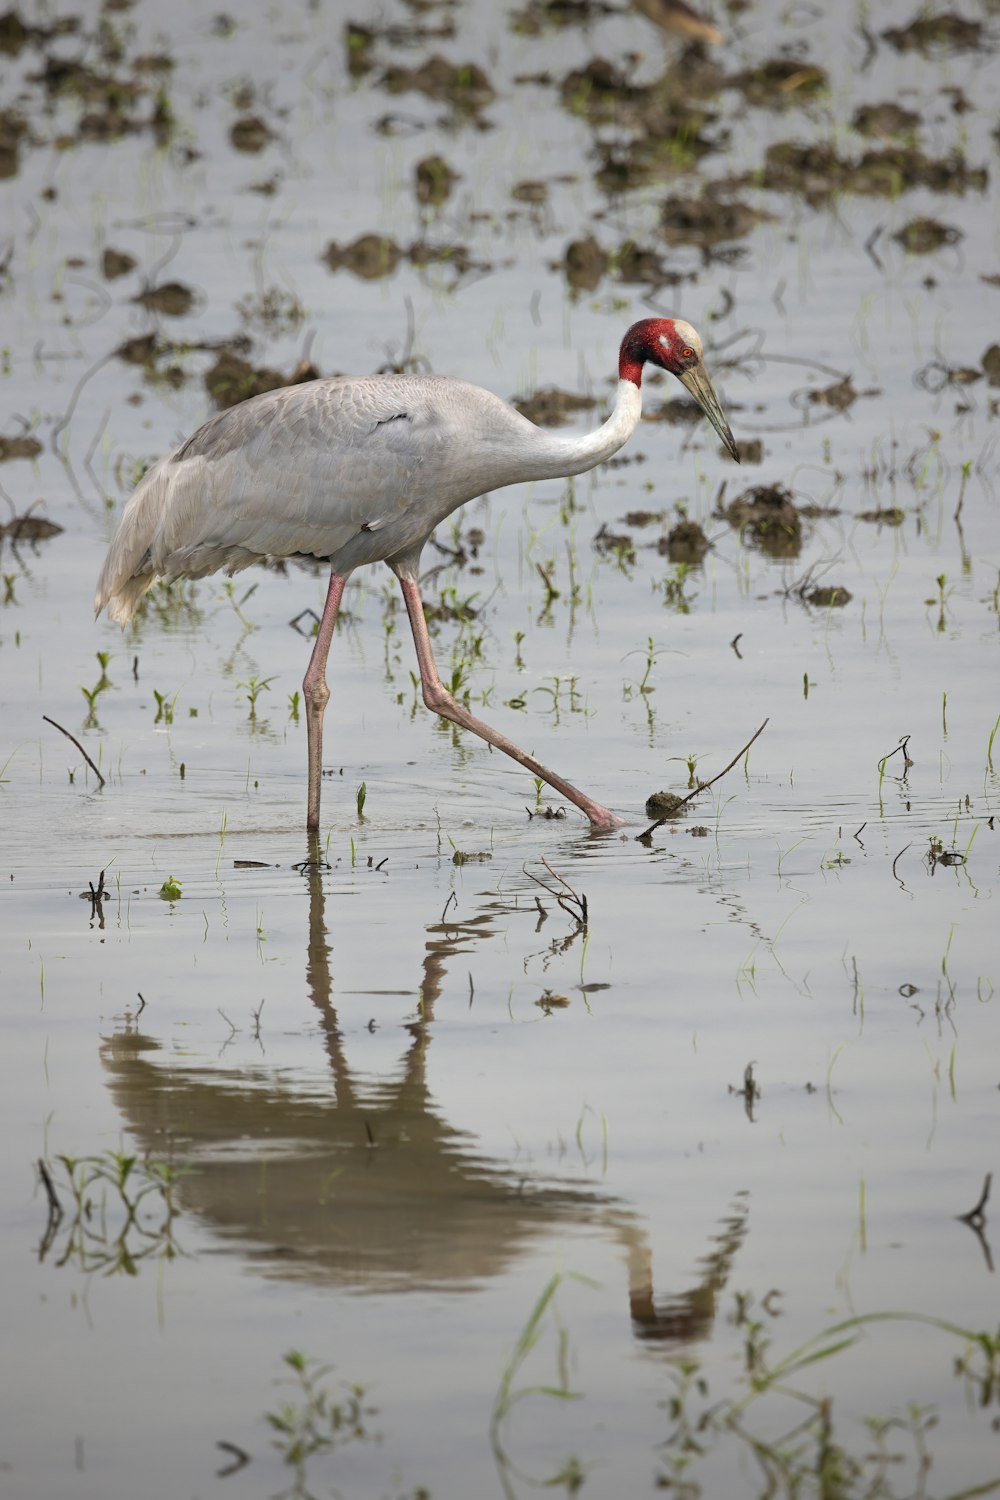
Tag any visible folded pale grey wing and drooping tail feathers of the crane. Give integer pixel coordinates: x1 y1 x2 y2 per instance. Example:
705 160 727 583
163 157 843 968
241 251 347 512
96 377 446 624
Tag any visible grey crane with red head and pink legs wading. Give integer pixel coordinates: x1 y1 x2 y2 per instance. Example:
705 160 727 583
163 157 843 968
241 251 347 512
94 318 739 831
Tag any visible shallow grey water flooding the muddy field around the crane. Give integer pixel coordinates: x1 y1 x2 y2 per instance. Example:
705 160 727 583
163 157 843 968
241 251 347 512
0 0 1000 1497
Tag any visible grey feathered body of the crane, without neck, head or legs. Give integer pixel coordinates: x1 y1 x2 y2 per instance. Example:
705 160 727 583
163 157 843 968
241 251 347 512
96 375 575 624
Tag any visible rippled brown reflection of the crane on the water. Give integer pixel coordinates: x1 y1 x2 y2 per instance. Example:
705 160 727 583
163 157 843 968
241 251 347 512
102 839 747 1346
